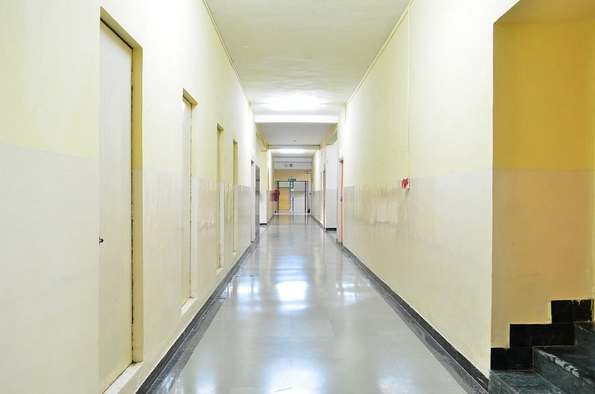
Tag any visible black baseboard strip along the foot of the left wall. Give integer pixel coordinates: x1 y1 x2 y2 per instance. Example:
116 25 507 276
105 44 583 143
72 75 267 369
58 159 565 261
137 244 254 393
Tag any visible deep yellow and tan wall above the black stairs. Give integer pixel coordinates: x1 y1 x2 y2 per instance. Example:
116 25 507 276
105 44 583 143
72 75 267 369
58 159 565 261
492 17 595 347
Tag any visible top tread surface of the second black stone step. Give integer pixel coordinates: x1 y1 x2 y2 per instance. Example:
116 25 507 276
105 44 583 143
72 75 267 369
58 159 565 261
537 346 595 386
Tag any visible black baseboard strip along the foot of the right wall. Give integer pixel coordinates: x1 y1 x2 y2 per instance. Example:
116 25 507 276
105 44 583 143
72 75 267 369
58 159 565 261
343 245 489 393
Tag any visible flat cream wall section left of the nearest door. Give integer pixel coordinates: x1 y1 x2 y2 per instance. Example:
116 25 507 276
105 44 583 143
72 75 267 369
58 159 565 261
0 0 99 393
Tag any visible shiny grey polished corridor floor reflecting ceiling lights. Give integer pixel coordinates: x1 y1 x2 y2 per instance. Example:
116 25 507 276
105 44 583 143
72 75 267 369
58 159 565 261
151 216 465 394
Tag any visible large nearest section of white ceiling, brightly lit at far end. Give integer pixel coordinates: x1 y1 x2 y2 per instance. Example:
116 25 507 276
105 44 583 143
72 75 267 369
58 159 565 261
207 0 408 118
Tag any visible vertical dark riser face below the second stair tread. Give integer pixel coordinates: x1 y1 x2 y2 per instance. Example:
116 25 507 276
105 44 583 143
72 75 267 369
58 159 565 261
533 350 595 394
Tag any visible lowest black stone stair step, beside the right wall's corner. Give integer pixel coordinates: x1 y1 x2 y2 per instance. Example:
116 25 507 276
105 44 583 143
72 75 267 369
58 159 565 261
490 371 564 394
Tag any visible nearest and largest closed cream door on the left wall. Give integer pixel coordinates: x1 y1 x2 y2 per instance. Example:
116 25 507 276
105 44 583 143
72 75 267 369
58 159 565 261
99 23 132 390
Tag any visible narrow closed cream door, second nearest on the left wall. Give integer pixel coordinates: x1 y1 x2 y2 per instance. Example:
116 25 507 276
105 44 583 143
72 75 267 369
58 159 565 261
181 99 192 303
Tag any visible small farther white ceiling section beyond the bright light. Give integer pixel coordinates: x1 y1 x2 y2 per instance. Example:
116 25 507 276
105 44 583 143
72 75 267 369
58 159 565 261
258 123 336 146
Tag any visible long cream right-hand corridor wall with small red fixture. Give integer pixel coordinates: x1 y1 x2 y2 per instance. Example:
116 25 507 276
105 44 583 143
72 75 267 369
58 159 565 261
338 0 515 375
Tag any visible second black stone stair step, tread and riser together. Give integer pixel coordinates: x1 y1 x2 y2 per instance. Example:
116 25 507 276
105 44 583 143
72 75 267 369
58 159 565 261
533 346 595 394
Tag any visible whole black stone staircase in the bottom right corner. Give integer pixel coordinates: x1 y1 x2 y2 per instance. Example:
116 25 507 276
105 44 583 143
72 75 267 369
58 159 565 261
490 300 595 394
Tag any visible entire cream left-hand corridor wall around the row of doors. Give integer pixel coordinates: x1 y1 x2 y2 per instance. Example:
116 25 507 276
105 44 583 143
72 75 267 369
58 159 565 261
0 0 268 394
